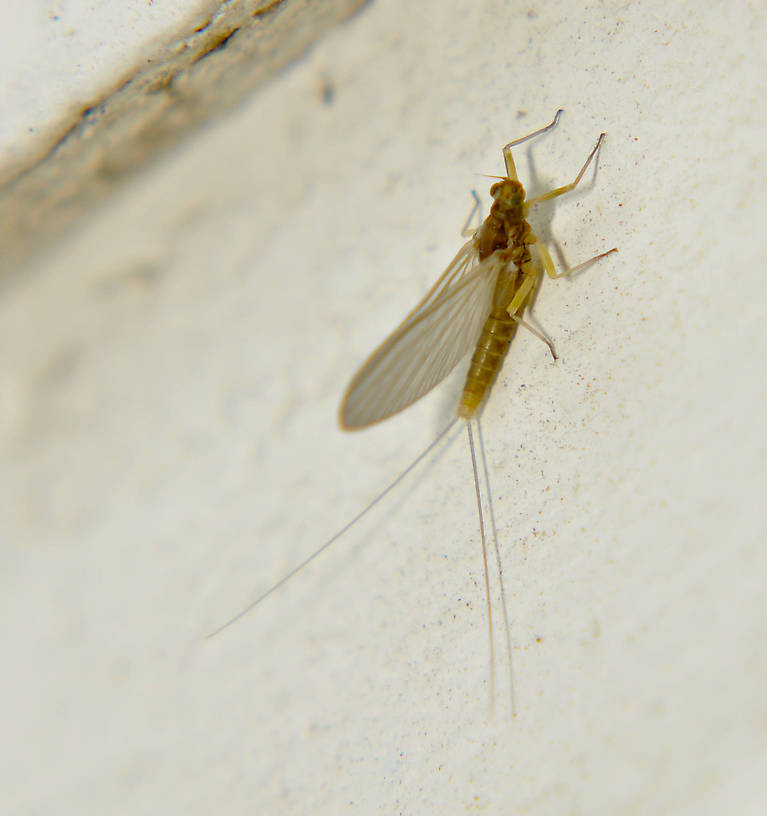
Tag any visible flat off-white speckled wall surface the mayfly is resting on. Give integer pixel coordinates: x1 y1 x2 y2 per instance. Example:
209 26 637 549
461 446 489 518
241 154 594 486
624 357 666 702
0 1 767 816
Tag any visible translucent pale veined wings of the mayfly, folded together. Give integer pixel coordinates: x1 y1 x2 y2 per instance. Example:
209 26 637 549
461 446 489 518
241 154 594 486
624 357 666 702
340 241 507 430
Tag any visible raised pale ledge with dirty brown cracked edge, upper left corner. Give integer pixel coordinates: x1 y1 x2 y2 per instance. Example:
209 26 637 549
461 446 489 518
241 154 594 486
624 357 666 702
0 0 365 276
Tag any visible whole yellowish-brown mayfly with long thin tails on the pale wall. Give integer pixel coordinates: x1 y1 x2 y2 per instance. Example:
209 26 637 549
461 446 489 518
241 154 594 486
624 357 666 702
212 110 617 710
